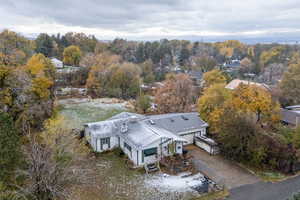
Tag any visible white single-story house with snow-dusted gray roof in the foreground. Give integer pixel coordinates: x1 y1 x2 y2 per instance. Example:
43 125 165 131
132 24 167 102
84 112 208 166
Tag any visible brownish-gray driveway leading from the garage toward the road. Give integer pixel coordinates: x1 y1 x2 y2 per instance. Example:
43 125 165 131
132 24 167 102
186 145 260 189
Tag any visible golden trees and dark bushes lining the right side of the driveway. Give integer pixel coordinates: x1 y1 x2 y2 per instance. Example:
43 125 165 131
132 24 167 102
198 65 300 173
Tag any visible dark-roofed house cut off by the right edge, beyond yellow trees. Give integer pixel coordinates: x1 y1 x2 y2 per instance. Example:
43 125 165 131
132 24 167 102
281 105 300 126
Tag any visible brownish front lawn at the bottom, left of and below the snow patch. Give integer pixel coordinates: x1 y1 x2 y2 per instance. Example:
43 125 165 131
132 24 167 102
71 151 202 200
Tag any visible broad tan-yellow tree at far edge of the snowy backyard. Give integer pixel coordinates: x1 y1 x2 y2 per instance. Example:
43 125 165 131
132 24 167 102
86 53 141 98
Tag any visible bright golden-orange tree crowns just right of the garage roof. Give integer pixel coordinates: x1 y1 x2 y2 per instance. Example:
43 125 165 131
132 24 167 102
198 84 280 133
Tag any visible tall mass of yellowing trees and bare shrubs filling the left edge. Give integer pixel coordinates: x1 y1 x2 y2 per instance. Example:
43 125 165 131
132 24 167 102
0 31 88 200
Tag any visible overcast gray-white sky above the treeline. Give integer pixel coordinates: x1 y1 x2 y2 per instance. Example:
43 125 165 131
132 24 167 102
0 0 300 39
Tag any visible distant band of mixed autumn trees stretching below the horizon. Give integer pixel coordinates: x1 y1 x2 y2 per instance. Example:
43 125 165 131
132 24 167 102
0 30 300 100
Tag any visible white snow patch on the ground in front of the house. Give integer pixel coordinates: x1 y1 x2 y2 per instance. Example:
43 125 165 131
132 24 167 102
145 172 205 192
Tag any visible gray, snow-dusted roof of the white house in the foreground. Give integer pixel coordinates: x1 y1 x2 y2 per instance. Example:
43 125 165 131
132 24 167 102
85 112 208 148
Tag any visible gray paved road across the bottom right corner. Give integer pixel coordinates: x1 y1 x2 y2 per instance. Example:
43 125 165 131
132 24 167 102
228 176 300 200
